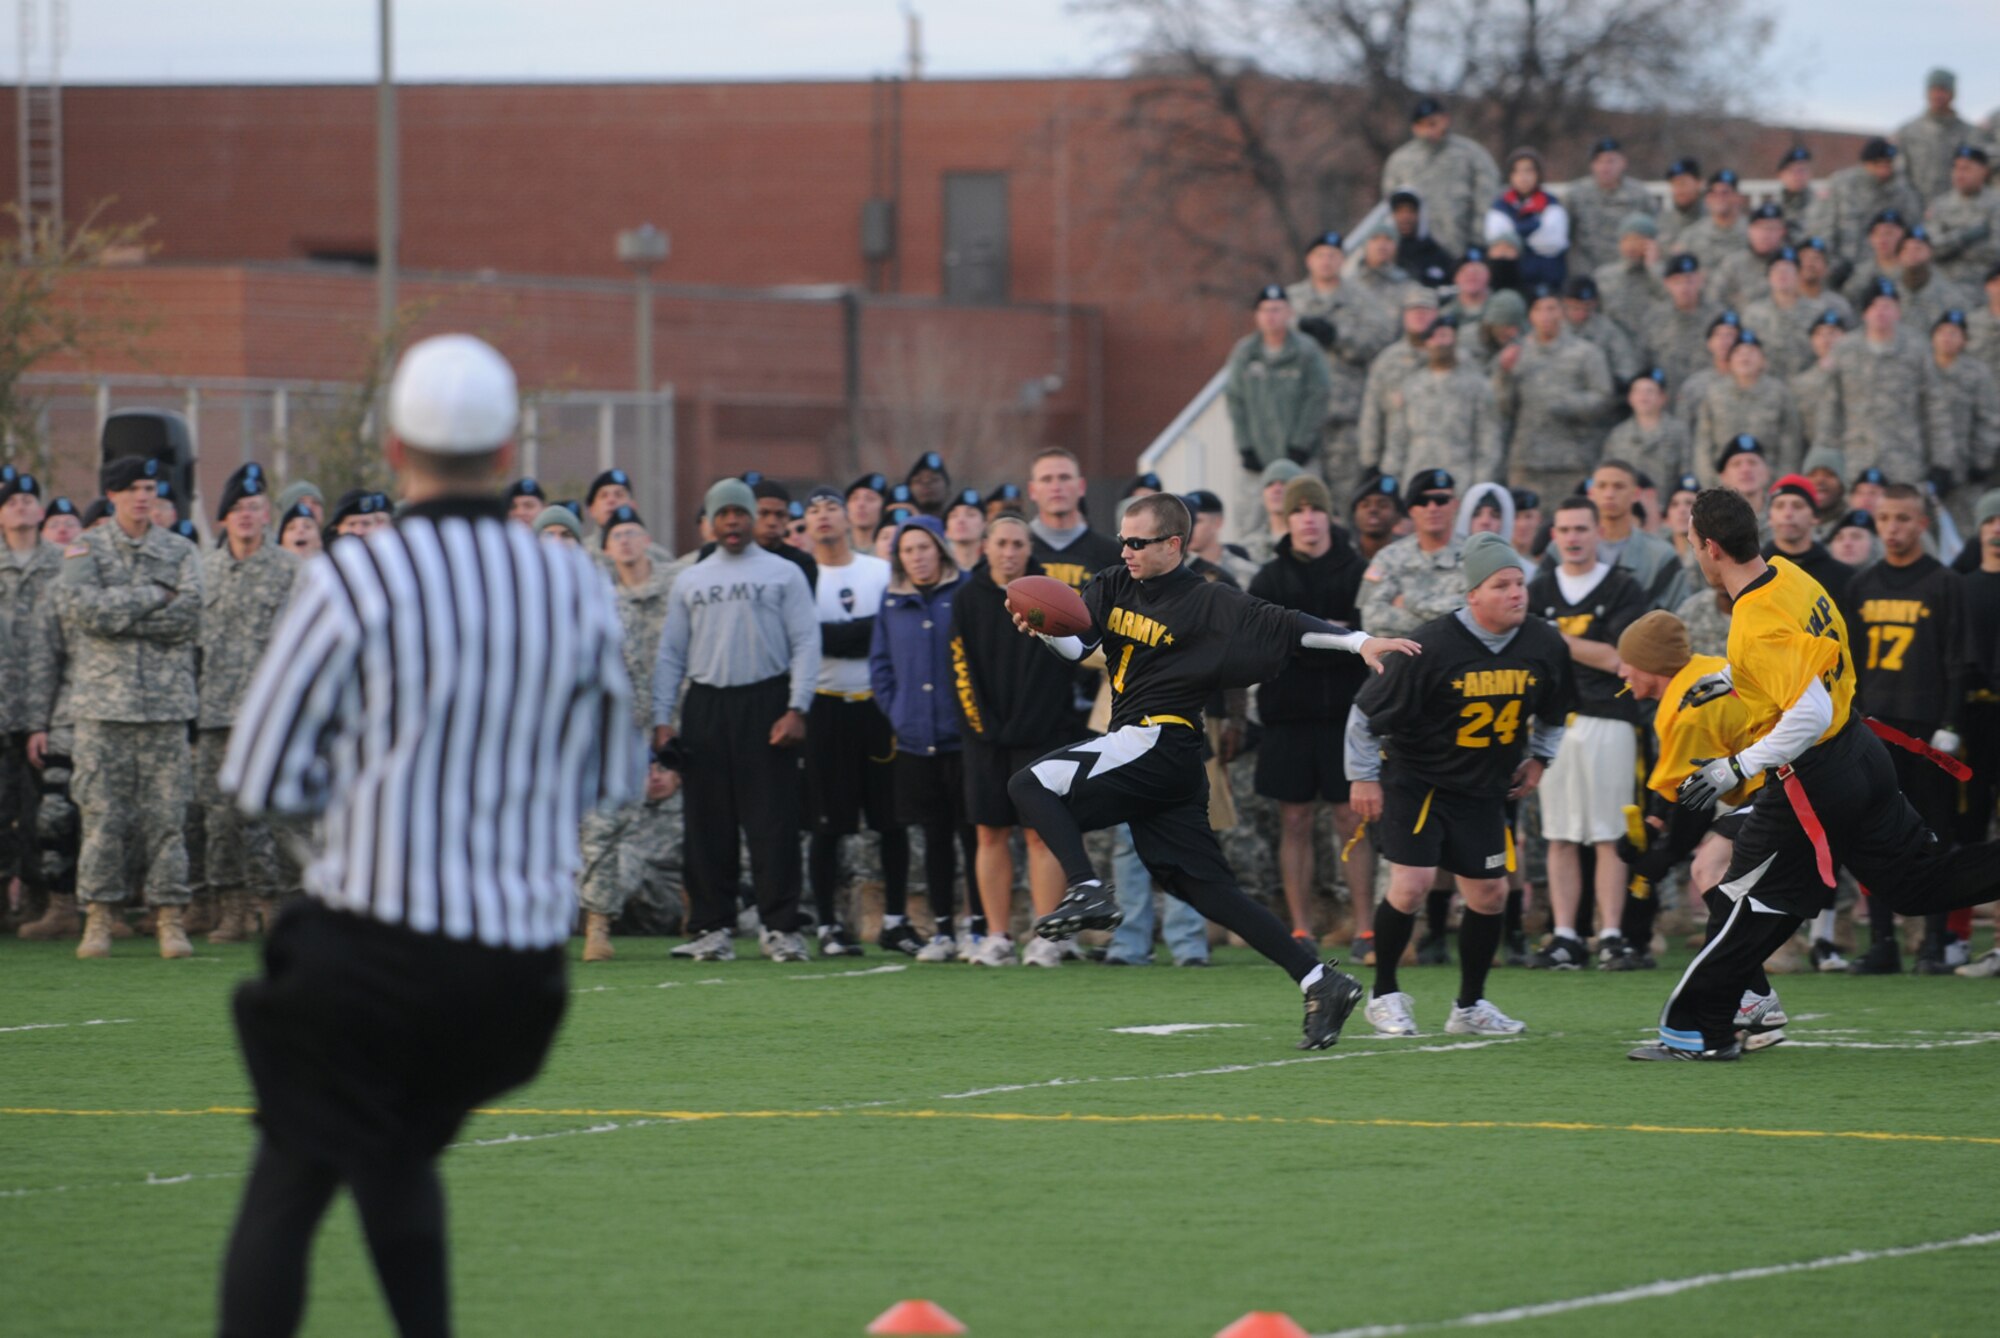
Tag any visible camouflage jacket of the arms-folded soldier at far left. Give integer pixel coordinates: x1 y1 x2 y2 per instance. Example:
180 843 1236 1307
56 520 202 724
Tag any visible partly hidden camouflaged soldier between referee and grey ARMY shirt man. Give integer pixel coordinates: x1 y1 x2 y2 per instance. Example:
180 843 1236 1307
576 506 688 962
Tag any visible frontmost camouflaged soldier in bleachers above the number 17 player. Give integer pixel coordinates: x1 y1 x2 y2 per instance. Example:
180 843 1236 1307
1832 280 1958 486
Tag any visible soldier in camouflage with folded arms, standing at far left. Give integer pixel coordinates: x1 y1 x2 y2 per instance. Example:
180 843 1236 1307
56 456 202 958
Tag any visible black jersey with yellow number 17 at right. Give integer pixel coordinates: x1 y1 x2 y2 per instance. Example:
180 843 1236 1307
1848 554 1964 730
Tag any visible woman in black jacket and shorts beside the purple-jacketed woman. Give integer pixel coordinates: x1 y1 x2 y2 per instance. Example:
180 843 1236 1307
952 516 1078 966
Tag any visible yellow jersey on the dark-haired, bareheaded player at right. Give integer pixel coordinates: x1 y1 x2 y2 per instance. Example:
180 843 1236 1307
1718 558 1854 756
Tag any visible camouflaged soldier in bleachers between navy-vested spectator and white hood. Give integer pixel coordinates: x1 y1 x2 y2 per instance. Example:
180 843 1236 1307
1504 288 1614 498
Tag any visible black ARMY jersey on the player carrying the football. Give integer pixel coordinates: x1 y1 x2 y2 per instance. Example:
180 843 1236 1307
1084 564 1320 730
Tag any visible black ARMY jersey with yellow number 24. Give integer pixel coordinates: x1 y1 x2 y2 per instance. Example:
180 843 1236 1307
1354 614 1576 798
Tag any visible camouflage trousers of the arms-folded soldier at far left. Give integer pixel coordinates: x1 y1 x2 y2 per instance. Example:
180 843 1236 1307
70 720 194 906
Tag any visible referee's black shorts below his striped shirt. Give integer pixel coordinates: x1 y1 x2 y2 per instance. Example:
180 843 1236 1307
234 898 570 1168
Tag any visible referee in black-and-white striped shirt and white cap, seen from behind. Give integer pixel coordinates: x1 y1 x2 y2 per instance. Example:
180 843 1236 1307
220 334 642 1338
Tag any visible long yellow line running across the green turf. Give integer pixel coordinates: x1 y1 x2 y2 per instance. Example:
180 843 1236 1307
11 1106 2000 1146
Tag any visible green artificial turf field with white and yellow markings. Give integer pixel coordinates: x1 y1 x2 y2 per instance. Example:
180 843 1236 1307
0 940 2000 1338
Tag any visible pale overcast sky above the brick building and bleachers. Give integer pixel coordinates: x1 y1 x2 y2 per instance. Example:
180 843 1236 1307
15 0 2000 128
